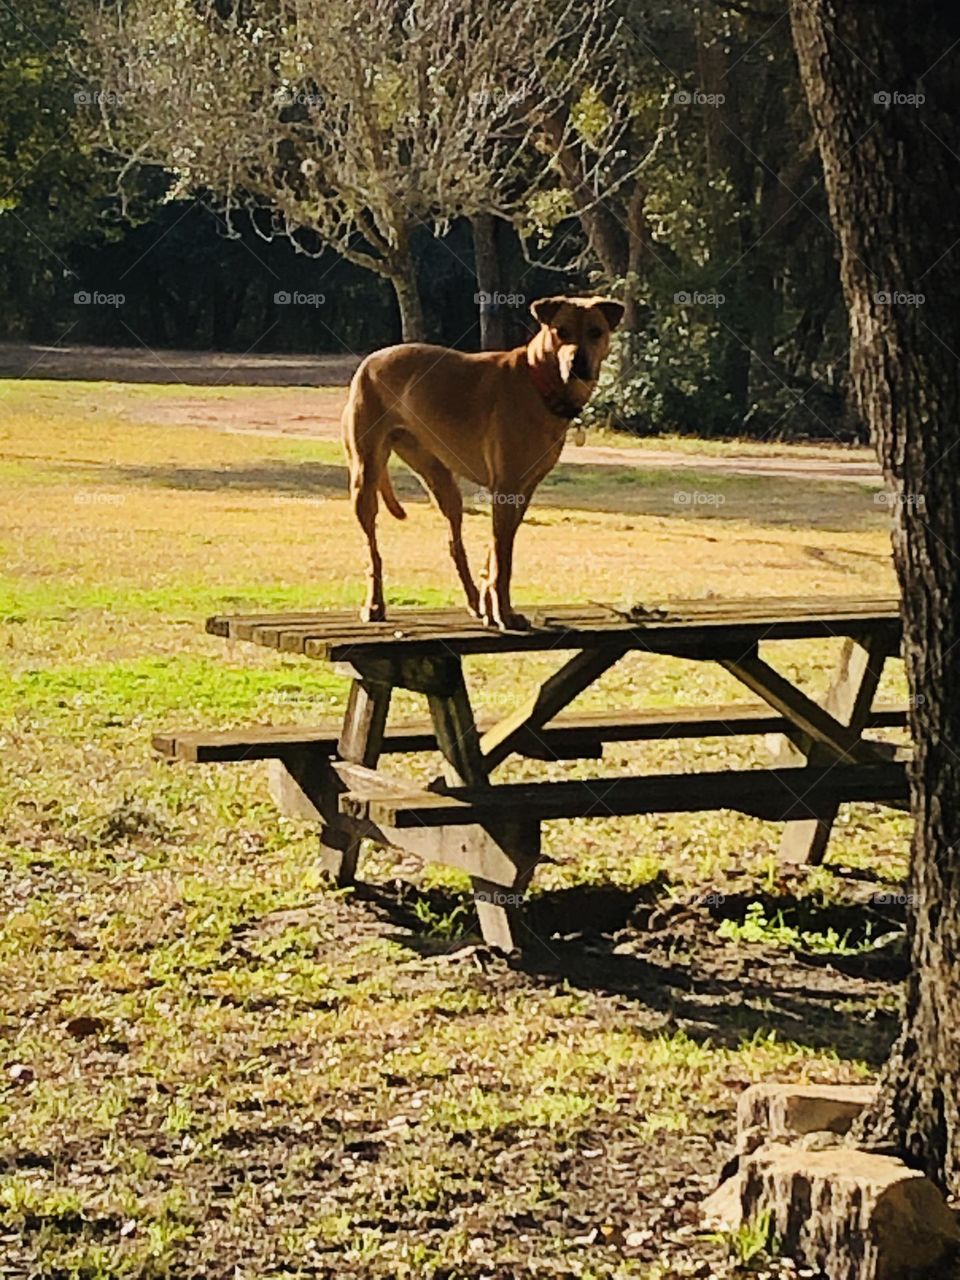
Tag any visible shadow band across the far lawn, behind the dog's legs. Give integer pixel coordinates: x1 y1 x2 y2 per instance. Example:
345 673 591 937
75 458 887 532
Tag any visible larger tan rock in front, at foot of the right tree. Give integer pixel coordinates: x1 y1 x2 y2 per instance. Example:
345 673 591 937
703 1143 960 1280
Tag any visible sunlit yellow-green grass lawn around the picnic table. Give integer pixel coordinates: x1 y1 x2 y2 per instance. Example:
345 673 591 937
0 383 908 1280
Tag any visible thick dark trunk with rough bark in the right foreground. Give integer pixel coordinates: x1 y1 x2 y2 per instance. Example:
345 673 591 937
791 0 960 1192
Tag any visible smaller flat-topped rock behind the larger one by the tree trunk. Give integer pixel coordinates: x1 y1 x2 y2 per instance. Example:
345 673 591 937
737 1084 877 1149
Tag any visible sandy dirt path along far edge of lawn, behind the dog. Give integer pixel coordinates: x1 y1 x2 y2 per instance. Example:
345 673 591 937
0 343 881 486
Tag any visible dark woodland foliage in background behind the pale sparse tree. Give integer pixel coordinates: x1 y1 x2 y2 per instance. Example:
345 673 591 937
0 0 861 439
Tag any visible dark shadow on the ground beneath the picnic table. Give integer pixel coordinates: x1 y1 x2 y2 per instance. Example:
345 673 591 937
357 882 905 1066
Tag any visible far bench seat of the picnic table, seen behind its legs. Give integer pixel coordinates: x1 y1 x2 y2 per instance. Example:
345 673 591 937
152 703 906 764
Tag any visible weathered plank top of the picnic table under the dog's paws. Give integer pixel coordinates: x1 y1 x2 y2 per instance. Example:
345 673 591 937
206 595 901 662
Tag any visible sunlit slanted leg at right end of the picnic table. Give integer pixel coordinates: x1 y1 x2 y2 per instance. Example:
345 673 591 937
778 635 887 864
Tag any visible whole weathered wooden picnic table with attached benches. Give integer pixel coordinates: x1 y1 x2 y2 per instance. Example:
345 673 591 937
154 598 909 950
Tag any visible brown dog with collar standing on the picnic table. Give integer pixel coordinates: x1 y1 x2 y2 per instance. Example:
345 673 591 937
343 291 623 630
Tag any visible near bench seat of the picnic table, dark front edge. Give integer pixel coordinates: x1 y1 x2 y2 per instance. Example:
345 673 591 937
340 762 909 828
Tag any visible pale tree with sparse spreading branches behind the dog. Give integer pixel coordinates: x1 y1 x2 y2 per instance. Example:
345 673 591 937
79 0 627 338
